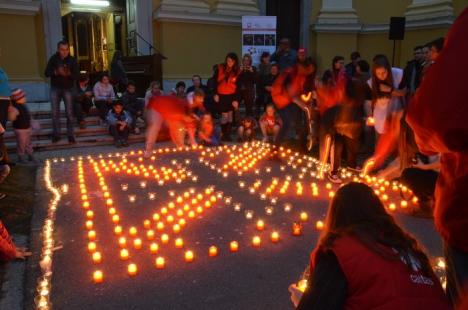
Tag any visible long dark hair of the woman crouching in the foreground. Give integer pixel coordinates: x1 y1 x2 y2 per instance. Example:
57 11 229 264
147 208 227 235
319 182 434 277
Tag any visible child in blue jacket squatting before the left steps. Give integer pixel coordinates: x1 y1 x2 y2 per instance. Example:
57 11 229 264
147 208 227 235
107 101 132 147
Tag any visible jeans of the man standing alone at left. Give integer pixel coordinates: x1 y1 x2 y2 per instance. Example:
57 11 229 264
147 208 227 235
50 87 74 138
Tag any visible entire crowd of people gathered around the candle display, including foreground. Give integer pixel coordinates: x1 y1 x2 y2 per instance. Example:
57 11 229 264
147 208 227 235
0 10 468 309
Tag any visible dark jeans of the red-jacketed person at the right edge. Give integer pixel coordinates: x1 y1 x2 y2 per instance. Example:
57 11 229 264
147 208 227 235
444 244 468 304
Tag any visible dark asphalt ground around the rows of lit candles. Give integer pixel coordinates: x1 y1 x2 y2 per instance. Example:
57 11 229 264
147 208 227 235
25 145 441 310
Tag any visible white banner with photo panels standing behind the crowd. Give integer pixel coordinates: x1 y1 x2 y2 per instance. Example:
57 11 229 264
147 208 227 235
242 16 276 65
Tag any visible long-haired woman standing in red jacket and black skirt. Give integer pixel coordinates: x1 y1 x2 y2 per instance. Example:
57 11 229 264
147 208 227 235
213 53 240 141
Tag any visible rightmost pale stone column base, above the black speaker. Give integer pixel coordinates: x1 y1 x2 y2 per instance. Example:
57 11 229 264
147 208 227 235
405 0 455 28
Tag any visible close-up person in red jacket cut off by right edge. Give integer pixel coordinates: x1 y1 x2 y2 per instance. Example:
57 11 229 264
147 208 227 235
406 9 468 305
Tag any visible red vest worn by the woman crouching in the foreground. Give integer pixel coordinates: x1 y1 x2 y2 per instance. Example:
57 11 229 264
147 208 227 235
311 236 450 310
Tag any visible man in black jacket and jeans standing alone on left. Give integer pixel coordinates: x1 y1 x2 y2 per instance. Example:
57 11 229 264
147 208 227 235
45 40 79 143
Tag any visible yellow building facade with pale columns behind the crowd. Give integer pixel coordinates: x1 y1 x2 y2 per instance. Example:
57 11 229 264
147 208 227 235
0 0 468 101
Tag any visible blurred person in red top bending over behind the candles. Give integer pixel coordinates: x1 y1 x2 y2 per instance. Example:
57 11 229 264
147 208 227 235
145 89 205 157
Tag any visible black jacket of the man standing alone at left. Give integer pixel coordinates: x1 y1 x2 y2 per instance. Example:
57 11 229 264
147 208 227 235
45 53 79 89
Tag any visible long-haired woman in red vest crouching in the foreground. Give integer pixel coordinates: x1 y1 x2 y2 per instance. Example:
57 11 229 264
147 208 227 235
290 183 450 310
